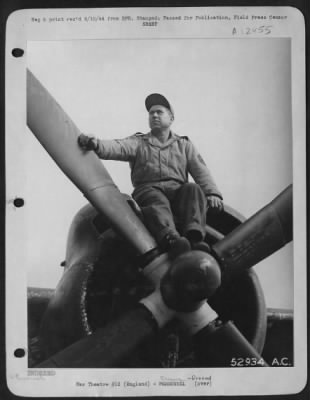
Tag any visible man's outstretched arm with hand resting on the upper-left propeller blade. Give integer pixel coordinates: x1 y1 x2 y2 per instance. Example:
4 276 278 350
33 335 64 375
78 134 139 161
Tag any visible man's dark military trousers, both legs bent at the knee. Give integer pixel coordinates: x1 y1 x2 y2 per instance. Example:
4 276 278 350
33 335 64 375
132 181 207 243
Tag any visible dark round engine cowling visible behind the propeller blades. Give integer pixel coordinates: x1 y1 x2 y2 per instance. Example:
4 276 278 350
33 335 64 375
34 205 266 367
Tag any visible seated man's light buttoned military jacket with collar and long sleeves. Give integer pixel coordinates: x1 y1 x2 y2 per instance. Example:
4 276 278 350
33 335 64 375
95 132 222 198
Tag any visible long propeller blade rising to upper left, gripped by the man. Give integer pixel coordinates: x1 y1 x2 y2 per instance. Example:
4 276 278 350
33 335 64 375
27 70 156 254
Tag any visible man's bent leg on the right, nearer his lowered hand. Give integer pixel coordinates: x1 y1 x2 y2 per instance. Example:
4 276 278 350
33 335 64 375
173 183 208 251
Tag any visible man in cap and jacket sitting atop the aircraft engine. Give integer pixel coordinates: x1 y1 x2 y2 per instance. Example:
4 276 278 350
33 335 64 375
78 93 223 256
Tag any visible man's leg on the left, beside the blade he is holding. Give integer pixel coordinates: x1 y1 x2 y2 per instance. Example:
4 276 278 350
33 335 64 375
133 186 190 254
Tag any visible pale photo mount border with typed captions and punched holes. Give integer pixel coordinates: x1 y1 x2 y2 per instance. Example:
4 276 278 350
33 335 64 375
5 7 307 397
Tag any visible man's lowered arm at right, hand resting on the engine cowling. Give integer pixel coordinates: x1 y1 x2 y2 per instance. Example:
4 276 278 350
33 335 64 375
187 140 223 209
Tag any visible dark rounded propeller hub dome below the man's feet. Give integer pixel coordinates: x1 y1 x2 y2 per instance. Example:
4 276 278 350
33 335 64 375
160 250 221 312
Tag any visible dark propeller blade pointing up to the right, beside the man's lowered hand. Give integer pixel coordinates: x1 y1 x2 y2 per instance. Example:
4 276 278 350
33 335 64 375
212 185 293 278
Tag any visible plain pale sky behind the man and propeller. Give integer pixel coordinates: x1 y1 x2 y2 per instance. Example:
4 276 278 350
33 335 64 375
23 39 293 308
